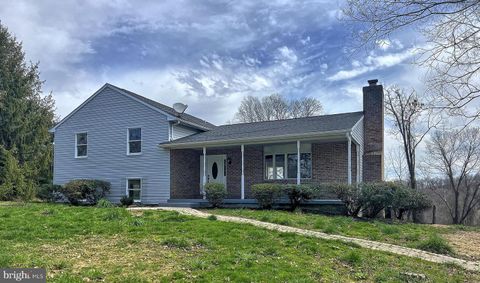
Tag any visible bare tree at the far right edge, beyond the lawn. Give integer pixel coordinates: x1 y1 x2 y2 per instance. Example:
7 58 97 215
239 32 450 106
426 128 480 224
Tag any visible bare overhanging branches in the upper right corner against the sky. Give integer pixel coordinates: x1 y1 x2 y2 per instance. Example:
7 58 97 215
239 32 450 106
343 0 480 122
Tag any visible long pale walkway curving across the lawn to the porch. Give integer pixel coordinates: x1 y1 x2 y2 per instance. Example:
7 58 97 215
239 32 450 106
129 207 480 272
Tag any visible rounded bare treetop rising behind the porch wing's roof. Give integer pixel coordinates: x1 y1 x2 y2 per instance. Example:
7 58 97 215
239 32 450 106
235 94 323 123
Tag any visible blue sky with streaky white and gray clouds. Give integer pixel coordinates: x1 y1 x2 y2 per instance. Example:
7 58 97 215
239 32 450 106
0 0 432 179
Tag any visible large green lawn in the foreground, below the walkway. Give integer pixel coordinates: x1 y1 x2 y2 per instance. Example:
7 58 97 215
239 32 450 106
0 203 480 282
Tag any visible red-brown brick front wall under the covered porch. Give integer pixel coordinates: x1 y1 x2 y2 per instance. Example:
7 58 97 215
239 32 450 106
170 141 357 199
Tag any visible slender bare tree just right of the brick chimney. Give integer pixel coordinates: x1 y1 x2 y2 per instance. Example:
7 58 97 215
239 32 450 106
385 86 438 189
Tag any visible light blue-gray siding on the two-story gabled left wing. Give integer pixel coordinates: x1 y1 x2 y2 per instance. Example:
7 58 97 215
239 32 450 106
54 86 170 204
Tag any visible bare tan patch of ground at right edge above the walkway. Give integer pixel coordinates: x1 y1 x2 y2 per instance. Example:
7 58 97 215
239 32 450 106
443 231 480 260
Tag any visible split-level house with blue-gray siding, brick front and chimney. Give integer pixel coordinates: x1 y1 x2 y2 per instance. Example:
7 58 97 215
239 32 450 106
51 80 384 204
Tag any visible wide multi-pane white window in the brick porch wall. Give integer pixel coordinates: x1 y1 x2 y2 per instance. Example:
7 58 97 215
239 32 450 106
264 144 312 180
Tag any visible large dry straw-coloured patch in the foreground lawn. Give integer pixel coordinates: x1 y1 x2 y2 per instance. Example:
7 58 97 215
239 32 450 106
38 236 198 281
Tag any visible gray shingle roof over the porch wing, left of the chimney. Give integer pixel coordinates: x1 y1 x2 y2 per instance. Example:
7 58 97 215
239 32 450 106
164 111 363 146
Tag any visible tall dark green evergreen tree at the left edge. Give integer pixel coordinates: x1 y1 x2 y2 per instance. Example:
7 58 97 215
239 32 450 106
0 22 55 195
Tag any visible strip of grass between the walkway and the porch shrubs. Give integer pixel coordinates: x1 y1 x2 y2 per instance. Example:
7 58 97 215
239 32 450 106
206 209 478 254
